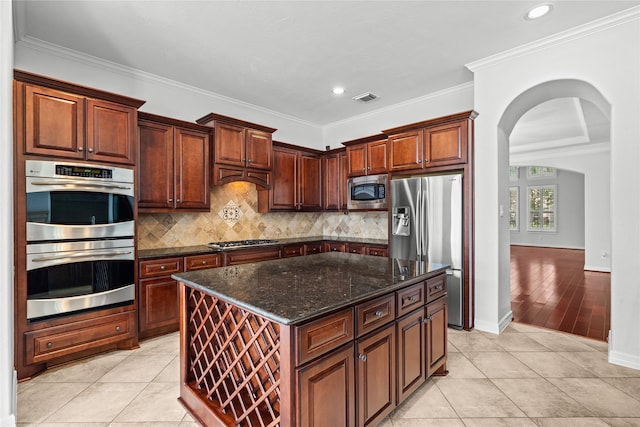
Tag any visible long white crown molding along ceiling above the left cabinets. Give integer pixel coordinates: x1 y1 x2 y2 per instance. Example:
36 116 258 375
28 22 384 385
16 36 322 129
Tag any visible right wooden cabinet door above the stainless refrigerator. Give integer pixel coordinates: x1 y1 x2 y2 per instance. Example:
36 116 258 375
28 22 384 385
424 120 468 166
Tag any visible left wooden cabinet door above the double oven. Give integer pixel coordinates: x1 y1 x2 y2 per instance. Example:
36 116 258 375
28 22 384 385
24 85 85 159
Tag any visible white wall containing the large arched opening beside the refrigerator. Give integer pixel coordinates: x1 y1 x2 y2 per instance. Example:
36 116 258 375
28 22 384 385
470 7 640 369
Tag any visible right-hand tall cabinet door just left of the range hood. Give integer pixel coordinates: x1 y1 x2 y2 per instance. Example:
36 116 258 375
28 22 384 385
175 128 209 210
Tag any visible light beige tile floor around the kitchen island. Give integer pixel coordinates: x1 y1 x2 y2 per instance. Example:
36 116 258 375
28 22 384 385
18 323 640 427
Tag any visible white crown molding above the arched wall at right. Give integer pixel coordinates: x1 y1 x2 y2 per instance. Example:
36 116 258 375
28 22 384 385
465 6 640 73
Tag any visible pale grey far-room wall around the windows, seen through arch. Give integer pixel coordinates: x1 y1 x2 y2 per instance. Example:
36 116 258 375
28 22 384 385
509 168 584 249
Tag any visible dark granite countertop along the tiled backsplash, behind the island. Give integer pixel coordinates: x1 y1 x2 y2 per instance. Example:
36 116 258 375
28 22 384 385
138 236 388 259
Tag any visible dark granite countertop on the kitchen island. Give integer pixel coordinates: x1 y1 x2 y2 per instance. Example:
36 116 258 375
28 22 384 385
172 252 448 325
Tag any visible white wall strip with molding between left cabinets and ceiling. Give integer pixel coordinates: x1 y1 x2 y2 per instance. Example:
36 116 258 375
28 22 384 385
15 41 324 150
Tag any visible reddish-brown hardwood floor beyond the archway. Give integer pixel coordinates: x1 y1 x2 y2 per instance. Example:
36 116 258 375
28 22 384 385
511 246 611 341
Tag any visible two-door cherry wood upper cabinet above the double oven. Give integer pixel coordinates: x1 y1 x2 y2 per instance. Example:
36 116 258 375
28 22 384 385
14 70 144 165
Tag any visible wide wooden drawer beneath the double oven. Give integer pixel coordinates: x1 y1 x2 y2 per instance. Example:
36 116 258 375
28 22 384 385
25 311 136 364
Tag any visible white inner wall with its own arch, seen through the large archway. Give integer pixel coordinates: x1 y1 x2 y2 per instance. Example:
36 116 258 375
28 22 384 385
510 150 611 272
